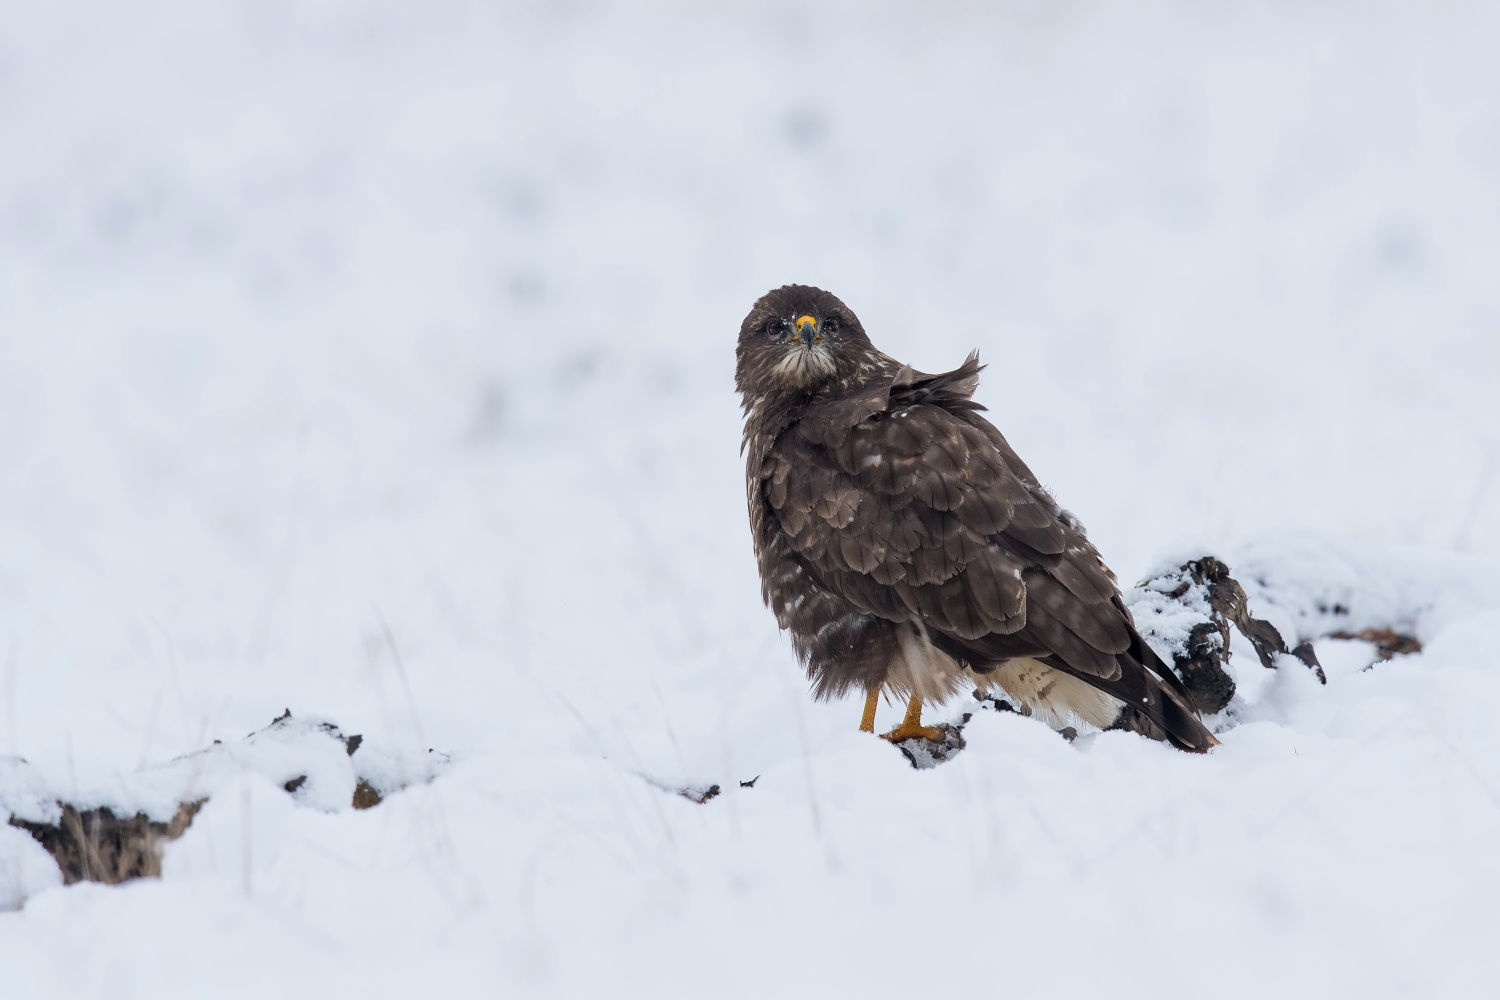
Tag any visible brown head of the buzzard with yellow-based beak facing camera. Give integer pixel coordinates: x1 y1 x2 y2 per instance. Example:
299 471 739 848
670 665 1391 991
735 285 870 397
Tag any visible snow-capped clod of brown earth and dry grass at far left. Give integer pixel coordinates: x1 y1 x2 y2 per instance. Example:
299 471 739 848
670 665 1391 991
0 709 447 903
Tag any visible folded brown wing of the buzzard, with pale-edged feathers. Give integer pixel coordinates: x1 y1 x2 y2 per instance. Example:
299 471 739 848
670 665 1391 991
761 355 1212 748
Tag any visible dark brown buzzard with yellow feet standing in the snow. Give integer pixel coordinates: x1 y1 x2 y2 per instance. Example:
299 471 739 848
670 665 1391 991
735 285 1218 751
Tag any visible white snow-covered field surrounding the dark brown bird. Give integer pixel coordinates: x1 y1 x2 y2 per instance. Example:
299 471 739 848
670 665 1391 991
0 0 1500 997
